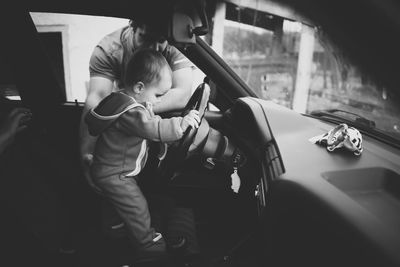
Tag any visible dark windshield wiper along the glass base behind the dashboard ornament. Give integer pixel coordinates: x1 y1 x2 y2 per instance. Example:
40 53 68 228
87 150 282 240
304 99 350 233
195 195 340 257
304 109 400 151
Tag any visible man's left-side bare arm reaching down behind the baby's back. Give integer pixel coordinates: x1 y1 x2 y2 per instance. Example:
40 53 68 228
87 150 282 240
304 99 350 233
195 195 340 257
79 77 113 192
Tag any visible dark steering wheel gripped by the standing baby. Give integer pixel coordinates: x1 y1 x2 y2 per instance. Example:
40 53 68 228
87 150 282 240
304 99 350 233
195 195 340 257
158 82 210 181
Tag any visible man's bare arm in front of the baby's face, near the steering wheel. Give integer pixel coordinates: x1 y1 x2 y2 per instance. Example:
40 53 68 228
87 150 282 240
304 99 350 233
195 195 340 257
153 67 193 113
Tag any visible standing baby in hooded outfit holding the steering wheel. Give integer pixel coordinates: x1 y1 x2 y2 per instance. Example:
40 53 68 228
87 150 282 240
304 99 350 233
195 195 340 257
85 49 200 254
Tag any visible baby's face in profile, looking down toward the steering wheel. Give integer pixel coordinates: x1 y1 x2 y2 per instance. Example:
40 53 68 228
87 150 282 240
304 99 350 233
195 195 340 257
136 66 172 104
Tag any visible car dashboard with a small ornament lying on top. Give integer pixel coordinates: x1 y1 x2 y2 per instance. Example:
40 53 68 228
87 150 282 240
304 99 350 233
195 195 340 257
222 98 400 266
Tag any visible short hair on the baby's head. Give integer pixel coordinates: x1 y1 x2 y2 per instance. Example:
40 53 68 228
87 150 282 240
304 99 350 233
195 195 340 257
125 48 171 87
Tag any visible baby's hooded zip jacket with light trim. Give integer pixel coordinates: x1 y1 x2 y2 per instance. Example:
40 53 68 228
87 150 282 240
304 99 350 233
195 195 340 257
85 91 183 179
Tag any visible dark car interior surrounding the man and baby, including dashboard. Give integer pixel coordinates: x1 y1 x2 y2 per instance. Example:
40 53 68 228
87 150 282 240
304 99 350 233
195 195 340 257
0 0 400 267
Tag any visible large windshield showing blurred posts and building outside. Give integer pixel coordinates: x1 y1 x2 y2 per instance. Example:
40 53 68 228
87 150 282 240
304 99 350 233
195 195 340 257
213 1 400 140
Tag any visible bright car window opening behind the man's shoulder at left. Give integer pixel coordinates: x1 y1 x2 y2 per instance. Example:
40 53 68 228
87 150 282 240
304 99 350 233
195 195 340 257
30 12 129 102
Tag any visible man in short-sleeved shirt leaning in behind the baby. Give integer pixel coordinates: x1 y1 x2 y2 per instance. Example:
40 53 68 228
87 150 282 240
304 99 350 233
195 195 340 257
80 21 193 190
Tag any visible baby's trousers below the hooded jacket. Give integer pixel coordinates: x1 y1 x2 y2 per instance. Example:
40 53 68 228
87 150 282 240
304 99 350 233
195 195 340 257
94 175 155 248
